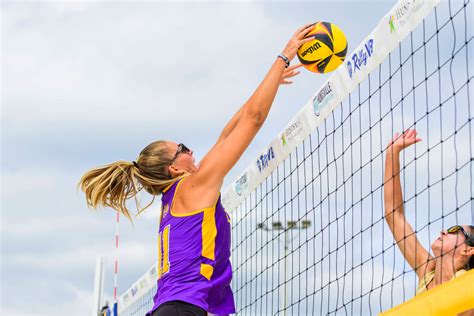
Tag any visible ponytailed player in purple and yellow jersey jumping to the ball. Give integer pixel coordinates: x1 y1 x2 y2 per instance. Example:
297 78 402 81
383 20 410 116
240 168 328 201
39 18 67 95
80 24 312 316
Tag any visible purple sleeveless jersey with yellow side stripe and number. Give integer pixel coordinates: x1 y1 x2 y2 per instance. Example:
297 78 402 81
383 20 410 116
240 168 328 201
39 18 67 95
147 180 235 315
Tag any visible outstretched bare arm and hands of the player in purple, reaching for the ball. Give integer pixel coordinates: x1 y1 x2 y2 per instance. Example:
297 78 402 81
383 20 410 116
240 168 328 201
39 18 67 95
186 24 312 204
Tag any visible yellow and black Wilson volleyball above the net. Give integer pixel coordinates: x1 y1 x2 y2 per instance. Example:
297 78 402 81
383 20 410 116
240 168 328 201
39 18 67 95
297 22 347 73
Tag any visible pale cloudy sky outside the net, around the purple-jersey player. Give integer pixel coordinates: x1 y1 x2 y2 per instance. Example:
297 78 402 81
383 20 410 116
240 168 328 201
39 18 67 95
0 1 470 315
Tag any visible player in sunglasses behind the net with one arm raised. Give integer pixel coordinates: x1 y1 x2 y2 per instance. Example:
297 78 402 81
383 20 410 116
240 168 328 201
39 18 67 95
384 129 474 294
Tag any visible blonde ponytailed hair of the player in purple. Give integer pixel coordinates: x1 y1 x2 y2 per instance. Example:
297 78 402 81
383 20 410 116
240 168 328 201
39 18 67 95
78 141 186 221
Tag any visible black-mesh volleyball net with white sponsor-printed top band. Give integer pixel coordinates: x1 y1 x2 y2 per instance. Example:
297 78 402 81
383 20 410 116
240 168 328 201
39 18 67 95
119 0 474 315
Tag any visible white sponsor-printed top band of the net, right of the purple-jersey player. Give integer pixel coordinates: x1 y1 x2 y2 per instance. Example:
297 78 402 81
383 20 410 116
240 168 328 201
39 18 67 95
223 0 440 215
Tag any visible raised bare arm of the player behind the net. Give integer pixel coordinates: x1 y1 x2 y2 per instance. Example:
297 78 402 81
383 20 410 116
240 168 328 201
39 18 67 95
384 130 433 278
